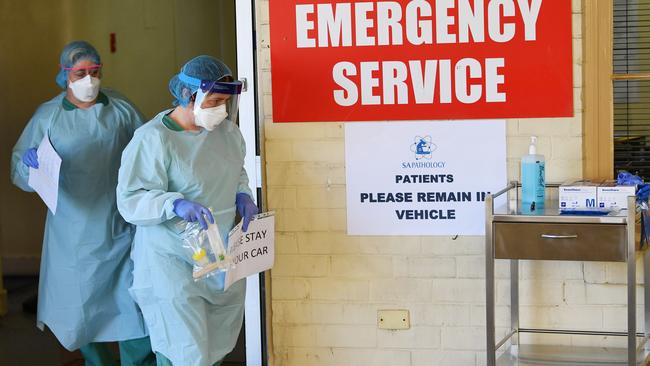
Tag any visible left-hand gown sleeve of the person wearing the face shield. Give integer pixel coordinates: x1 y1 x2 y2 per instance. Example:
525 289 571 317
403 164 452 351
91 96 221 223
117 129 183 225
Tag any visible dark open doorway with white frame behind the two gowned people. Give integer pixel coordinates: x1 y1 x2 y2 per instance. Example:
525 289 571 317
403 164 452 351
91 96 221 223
0 0 267 366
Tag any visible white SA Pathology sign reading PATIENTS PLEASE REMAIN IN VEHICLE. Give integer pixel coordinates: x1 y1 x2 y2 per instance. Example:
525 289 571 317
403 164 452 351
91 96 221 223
345 120 507 235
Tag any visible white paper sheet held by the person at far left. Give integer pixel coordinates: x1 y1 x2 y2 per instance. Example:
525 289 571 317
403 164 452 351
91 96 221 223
27 136 61 214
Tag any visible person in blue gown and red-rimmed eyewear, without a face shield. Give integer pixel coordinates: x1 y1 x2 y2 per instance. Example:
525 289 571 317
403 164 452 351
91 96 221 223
11 41 155 366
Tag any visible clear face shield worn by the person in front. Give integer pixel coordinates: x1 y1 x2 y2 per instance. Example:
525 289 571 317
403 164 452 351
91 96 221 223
194 80 242 123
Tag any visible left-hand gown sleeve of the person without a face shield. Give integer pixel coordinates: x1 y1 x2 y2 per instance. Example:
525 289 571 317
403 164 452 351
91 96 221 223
11 103 55 192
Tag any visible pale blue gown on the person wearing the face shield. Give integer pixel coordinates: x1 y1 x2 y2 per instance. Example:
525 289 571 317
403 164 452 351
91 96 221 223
117 111 251 366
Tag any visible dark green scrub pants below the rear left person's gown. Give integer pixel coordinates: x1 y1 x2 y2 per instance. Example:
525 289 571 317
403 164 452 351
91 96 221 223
80 337 156 366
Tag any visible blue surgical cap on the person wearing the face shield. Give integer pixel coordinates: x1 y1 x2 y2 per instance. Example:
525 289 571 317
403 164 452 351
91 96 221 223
169 55 232 107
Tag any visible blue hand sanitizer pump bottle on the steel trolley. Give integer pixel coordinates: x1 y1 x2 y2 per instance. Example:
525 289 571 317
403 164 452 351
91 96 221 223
521 136 546 211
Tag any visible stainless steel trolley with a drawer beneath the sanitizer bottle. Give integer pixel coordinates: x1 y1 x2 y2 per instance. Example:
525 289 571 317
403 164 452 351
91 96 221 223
485 182 650 366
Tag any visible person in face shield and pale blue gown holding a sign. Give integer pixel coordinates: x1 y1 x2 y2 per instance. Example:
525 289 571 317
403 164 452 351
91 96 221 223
117 56 257 366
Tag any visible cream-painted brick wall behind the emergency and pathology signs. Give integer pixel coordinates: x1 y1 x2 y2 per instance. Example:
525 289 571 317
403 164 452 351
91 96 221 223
257 0 632 366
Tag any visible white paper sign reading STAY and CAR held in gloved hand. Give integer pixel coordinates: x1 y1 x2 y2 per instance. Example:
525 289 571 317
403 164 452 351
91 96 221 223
225 212 275 289
